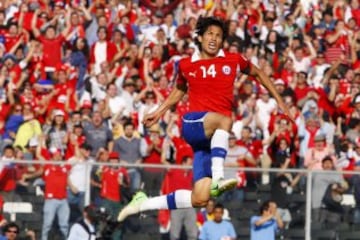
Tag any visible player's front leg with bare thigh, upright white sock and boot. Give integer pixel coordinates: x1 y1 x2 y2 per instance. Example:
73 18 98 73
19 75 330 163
204 112 237 197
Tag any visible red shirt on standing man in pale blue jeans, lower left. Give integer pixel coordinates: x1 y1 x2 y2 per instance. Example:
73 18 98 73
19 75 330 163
43 165 70 199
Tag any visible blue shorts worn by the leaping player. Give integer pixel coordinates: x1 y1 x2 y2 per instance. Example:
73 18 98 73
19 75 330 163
182 112 212 182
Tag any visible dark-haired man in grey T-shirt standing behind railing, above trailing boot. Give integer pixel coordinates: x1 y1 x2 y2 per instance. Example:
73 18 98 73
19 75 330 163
114 122 142 192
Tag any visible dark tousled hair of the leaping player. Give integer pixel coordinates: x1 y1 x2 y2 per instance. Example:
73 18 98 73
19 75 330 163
194 17 228 50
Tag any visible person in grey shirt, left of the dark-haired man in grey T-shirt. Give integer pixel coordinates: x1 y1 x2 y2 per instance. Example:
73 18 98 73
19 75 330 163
84 111 114 157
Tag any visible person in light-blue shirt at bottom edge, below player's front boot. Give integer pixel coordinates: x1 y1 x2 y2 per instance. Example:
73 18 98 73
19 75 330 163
199 203 236 240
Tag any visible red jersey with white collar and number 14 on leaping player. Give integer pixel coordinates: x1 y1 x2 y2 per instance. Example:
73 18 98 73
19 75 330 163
177 50 251 116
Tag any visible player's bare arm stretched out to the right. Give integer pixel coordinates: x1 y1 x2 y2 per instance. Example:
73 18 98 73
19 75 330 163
250 65 291 119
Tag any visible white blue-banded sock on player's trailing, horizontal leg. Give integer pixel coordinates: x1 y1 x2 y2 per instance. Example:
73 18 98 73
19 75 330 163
140 190 192 212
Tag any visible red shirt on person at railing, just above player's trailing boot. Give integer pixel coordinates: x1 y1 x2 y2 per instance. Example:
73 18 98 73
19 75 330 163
100 167 129 202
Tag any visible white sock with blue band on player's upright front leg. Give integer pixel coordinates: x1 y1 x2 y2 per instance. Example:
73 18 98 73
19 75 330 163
211 129 230 180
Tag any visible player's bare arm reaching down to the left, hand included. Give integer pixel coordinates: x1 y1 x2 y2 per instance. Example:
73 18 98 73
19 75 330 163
143 85 187 127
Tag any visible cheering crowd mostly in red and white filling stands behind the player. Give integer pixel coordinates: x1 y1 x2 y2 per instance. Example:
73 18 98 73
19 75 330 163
0 0 360 240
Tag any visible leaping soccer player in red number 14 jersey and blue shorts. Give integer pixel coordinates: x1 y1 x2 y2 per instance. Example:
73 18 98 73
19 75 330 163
118 17 288 222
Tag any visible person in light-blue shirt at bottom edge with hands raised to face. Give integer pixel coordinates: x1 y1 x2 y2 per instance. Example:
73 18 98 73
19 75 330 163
250 201 284 240
